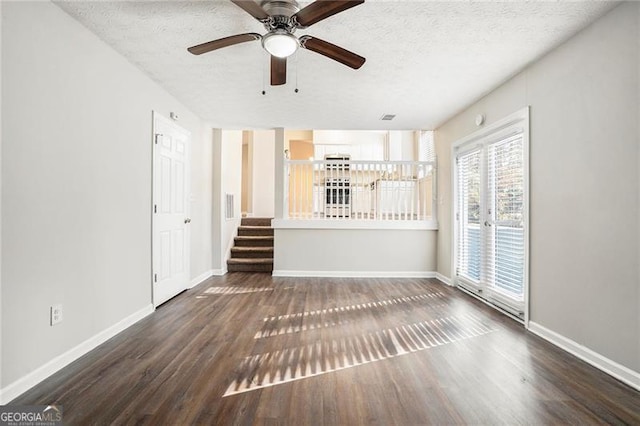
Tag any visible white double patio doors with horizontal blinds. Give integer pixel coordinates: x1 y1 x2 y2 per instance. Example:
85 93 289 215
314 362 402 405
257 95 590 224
455 110 528 319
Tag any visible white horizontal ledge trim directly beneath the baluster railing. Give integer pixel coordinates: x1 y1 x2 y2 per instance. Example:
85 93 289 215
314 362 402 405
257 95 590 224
271 219 438 231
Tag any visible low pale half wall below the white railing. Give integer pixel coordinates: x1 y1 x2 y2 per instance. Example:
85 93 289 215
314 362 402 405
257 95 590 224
274 228 437 277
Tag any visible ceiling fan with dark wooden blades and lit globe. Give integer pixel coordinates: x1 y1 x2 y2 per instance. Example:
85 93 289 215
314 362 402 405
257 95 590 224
187 0 365 86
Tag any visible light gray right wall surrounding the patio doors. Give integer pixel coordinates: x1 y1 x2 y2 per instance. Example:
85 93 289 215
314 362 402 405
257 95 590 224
436 2 640 372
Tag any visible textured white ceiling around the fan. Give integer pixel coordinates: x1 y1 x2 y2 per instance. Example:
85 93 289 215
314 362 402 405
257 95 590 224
56 0 615 129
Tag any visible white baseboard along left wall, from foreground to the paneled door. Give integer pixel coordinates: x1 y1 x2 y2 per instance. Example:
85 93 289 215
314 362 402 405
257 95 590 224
0 304 154 405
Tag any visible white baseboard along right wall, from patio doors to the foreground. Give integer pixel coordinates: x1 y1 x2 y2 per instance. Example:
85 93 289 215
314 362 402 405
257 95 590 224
529 321 640 390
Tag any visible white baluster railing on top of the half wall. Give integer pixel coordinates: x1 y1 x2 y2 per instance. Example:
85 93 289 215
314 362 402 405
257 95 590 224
285 160 436 221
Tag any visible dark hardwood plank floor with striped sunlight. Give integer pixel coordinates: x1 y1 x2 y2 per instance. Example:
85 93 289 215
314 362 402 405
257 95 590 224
13 273 640 425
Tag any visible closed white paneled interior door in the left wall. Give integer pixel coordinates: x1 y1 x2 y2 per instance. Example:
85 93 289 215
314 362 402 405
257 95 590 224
152 113 191 306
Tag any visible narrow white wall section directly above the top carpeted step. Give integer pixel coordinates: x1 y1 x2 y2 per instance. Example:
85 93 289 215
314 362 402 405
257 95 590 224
252 130 276 217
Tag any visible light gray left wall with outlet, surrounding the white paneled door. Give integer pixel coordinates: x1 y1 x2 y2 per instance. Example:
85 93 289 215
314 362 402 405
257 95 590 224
1 2 211 398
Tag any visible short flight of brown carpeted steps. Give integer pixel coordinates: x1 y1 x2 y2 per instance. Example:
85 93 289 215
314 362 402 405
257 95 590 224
227 217 273 272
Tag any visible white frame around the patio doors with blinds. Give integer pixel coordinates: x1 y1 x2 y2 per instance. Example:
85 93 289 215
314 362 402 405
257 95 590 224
451 106 530 328
